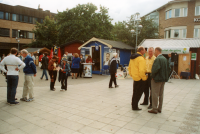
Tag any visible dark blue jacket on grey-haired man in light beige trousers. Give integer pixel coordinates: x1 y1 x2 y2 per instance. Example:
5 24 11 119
23 55 37 74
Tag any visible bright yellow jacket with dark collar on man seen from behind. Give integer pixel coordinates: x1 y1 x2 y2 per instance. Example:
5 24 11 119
128 52 147 81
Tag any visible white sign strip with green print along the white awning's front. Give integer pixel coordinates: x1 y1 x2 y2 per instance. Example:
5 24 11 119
149 47 190 54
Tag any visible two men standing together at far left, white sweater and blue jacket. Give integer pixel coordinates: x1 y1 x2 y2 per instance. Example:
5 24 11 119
0 48 37 105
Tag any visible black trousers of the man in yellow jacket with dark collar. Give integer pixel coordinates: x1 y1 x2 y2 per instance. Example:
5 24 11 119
132 80 146 109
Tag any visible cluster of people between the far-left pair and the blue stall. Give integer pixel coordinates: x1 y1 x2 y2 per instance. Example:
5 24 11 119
46 52 92 91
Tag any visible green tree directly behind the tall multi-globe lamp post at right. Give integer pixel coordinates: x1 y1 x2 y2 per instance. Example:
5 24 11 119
112 15 161 47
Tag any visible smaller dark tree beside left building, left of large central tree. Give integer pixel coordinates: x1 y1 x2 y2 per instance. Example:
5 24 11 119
29 16 58 48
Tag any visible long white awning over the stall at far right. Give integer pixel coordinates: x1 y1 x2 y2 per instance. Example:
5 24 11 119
139 38 200 54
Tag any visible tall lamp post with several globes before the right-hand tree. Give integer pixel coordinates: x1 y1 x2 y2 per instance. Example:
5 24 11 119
130 13 142 53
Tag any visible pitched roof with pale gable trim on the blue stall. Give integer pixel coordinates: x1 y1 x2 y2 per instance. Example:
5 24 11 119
78 37 134 50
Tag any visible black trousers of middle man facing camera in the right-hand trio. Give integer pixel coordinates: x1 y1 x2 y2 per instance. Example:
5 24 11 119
143 73 152 106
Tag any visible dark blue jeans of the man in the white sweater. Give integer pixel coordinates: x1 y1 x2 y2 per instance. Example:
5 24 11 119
7 75 19 103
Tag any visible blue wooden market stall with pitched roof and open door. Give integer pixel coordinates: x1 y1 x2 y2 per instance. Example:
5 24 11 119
78 38 134 74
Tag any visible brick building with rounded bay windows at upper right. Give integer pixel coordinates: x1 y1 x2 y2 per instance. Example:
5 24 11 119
145 0 200 39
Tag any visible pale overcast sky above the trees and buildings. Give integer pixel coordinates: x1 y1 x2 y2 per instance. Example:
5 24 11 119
0 0 170 24
